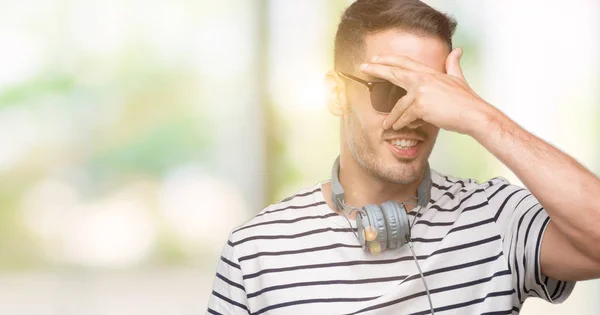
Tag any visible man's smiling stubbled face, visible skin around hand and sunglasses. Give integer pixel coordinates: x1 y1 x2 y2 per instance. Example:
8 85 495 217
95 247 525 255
342 30 449 184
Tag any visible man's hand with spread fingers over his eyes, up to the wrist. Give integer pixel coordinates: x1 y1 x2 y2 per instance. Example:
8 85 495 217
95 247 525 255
361 48 497 136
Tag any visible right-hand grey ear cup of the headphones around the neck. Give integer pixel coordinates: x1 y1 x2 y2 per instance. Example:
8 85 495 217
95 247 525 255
381 201 410 249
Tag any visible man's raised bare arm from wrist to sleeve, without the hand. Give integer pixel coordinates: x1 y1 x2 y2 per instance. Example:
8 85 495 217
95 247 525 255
471 111 600 280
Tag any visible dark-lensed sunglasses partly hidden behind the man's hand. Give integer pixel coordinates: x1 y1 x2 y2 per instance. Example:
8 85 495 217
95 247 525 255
338 72 407 114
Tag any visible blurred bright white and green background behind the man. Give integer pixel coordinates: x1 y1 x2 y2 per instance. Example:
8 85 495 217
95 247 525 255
0 0 600 315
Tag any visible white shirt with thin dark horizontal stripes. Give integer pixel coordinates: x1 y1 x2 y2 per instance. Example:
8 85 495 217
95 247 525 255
207 170 575 314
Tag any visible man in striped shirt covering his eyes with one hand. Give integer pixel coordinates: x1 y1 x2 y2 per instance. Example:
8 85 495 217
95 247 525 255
207 0 600 314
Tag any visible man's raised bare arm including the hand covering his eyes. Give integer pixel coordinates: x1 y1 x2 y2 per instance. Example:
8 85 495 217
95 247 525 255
361 49 600 280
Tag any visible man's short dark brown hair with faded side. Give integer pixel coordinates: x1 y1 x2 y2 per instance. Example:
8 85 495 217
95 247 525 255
334 0 456 71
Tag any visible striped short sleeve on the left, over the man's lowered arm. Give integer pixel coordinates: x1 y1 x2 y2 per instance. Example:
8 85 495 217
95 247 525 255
206 235 250 315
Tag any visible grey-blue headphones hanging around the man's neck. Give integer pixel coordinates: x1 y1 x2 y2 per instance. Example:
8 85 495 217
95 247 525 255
331 156 432 254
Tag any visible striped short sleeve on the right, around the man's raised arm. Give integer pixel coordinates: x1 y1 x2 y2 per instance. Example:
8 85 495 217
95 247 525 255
485 177 575 304
